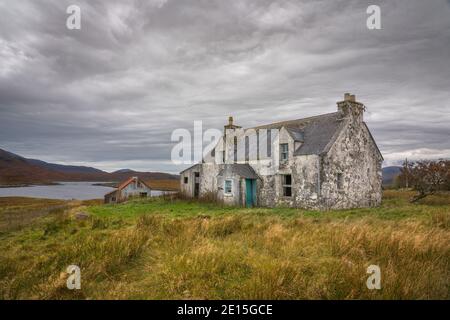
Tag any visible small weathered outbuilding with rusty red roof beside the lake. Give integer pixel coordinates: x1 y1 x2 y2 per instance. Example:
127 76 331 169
104 177 151 203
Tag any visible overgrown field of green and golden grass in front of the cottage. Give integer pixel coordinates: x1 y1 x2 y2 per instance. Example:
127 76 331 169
0 191 450 299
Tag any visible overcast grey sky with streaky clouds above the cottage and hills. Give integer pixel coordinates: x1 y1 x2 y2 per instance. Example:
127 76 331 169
0 0 450 172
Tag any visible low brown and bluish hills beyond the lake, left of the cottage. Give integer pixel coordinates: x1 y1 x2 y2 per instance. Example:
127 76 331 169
0 149 179 185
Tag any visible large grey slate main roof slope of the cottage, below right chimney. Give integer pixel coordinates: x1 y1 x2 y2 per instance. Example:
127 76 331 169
253 112 343 155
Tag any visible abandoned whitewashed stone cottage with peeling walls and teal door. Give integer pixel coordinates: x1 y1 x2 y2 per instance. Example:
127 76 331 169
180 93 383 210
